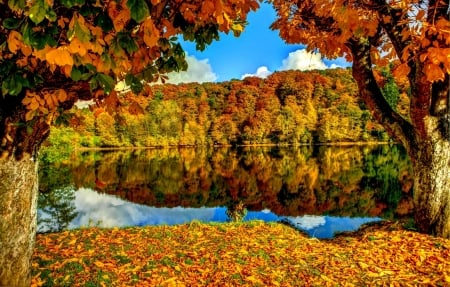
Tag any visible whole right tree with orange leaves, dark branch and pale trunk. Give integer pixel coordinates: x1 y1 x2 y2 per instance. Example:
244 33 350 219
271 0 450 238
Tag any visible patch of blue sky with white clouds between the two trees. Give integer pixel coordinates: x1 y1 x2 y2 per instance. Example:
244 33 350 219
169 3 349 82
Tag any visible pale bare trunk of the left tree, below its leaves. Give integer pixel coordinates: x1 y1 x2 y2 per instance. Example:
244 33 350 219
0 156 38 287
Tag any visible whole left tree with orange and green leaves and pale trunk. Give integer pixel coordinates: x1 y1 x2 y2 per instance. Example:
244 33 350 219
0 0 258 286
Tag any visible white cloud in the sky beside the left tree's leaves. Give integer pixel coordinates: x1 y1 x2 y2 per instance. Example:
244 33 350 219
166 55 217 84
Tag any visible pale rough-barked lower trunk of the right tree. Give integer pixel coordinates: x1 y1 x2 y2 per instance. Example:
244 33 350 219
410 119 450 238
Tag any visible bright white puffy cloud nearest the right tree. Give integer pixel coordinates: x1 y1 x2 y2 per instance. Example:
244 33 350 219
280 50 328 71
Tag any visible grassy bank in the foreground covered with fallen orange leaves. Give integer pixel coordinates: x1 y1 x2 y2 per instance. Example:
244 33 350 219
32 221 450 286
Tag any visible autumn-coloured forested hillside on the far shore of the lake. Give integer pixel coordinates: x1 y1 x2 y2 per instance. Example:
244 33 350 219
41 69 408 156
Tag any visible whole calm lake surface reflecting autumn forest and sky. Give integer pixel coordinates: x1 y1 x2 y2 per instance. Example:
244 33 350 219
38 145 413 238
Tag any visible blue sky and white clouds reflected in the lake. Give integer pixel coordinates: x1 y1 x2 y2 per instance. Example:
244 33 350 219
38 188 380 238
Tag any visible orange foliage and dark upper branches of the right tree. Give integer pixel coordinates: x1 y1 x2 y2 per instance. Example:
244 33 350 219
271 0 450 153
